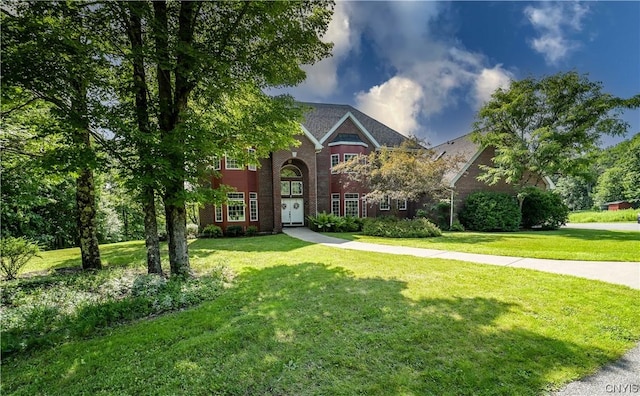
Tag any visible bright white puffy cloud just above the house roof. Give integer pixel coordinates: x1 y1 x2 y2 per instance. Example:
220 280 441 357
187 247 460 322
356 76 424 136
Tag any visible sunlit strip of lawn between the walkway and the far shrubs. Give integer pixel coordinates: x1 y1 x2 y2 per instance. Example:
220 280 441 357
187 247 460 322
326 229 640 261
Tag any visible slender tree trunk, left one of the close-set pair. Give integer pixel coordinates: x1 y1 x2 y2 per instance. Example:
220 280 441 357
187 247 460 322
127 2 162 274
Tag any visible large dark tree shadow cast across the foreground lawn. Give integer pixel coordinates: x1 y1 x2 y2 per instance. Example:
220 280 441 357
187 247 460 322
3 263 607 395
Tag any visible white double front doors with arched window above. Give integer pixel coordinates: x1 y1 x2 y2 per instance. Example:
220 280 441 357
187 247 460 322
280 165 304 226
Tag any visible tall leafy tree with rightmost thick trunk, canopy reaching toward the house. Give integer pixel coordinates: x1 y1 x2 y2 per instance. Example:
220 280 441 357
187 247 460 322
141 1 331 275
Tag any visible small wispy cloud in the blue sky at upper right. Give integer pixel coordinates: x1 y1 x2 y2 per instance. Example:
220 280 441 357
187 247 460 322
524 2 589 65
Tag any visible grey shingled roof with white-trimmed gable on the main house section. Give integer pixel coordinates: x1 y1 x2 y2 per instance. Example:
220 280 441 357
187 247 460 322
300 102 406 147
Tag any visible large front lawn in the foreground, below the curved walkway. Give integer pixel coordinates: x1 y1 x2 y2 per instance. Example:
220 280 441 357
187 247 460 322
2 235 640 395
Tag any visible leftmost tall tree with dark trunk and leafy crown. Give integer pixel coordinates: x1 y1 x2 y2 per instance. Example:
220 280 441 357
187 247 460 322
2 2 109 269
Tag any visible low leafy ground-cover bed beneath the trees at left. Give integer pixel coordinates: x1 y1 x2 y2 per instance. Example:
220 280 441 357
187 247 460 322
1 264 234 356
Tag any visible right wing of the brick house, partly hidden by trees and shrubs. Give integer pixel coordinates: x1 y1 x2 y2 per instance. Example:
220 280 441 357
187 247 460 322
432 134 555 224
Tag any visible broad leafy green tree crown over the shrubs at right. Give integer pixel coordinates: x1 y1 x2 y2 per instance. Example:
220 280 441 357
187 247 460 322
472 72 640 202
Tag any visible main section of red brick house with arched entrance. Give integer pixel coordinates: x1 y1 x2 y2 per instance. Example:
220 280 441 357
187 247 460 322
200 103 410 232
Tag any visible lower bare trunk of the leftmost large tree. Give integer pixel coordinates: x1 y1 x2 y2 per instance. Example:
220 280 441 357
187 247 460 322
76 166 102 270
